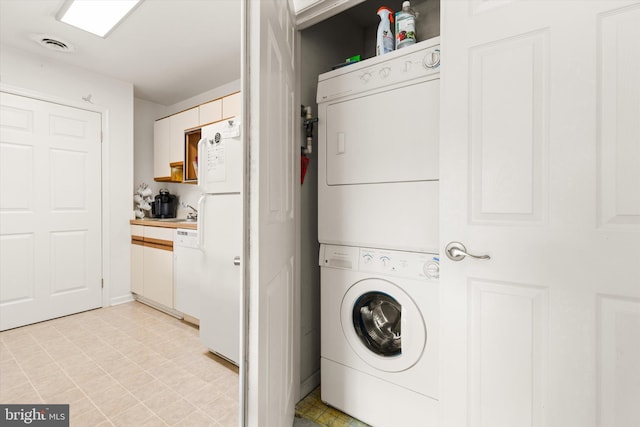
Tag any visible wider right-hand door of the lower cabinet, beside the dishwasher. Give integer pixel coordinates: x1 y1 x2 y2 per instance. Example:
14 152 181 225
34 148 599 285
144 246 173 308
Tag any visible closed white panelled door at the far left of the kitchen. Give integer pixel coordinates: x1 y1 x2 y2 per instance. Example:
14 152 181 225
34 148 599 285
0 92 102 330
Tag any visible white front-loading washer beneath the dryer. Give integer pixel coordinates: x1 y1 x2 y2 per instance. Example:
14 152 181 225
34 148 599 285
320 245 439 427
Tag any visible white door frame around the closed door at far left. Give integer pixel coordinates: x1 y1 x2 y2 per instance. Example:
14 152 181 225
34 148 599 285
0 83 111 307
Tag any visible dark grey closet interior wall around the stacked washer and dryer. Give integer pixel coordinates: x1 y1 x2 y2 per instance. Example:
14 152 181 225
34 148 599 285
299 0 440 412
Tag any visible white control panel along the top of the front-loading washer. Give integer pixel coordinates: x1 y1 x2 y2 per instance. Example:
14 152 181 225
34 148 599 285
319 245 440 280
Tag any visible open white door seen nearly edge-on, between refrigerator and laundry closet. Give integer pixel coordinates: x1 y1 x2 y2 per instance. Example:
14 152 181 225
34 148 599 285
243 0 300 427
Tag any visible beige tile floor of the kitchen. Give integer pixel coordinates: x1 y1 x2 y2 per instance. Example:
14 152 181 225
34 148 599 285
0 302 238 427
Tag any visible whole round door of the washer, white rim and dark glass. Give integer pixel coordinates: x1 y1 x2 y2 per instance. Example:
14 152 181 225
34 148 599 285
340 279 427 372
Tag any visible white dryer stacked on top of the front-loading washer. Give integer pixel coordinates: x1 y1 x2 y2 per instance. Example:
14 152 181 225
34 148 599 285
317 38 440 252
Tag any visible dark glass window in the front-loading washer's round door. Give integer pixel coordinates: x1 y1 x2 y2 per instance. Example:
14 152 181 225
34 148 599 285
353 291 402 357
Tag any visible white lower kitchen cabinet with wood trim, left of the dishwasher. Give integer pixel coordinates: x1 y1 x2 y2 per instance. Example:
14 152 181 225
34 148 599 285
131 225 174 308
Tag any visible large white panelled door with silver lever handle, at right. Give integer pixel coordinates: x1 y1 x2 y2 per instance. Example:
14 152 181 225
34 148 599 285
441 0 640 427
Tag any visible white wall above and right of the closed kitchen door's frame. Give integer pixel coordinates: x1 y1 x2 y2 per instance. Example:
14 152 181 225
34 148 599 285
0 45 133 305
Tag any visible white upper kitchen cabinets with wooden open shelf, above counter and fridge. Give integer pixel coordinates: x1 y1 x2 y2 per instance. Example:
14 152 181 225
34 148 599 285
153 92 241 183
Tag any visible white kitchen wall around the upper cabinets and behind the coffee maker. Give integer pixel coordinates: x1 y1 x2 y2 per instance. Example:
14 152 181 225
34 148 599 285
131 80 240 217
